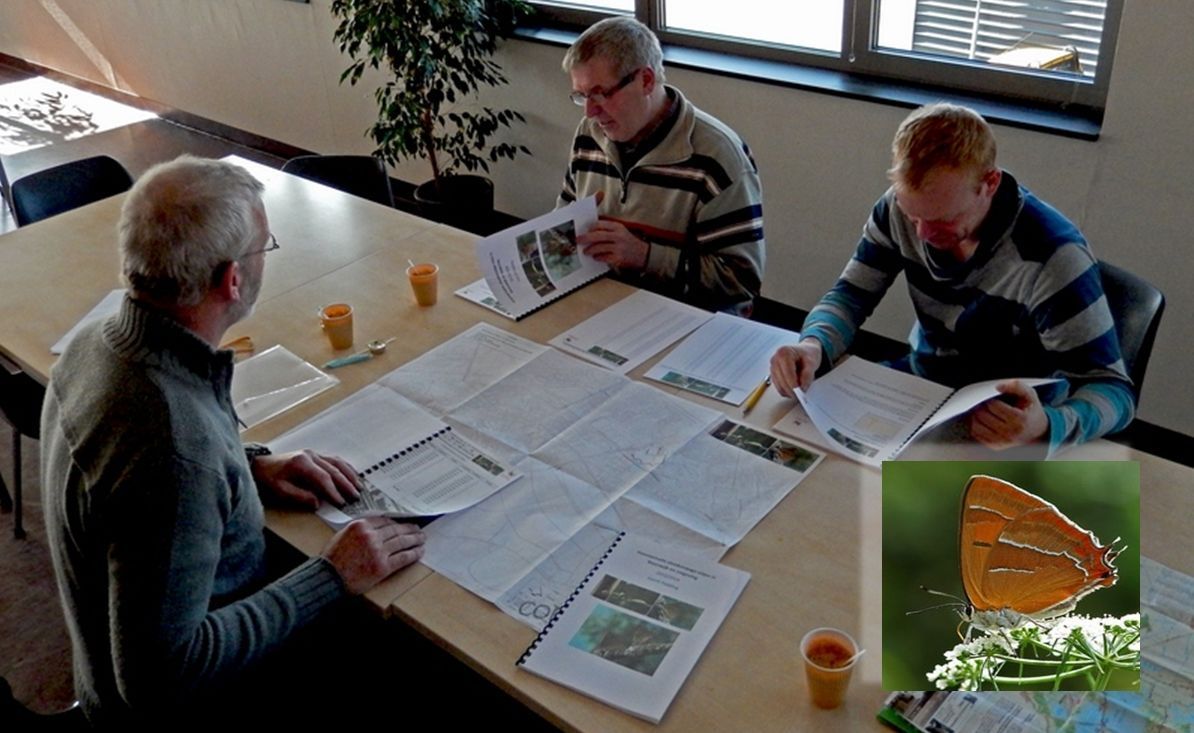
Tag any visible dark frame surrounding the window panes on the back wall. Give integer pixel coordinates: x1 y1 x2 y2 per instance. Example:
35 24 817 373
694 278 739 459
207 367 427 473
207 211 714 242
530 0 1124 124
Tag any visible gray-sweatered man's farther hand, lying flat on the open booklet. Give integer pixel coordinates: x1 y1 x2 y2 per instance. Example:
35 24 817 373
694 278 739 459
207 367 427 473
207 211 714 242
252 450 361 509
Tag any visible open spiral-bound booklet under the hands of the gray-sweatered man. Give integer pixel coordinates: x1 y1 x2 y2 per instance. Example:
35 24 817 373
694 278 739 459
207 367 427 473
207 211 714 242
270 384 519 526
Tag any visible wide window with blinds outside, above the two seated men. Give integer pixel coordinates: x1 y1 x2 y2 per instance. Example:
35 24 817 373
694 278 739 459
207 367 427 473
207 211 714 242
535 0 1122 118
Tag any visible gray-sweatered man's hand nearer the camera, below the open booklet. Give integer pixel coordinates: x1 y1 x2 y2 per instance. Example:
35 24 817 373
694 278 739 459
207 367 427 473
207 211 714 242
321 517 426 596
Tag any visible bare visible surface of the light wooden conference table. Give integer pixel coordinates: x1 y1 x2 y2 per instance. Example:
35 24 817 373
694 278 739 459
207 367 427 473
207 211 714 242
0 161 1194 731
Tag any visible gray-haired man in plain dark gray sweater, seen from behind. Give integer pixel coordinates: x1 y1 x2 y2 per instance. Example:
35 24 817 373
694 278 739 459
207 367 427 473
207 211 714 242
42 156 423 726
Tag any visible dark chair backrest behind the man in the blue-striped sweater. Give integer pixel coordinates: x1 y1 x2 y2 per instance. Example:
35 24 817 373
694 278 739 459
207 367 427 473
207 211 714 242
1098 261 1165 400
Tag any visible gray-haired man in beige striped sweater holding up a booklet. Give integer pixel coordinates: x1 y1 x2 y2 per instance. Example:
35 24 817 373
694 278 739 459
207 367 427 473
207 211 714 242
556 17 765 315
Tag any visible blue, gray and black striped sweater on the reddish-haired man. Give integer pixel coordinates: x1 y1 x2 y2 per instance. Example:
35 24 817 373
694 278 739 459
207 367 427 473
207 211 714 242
802 172 1135 456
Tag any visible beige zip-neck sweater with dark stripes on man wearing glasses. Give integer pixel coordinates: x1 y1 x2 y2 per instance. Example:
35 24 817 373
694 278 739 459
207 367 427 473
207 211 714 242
556 86 765 315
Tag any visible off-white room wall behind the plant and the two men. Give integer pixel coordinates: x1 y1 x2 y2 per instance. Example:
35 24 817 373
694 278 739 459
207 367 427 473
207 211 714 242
0 0 1194 435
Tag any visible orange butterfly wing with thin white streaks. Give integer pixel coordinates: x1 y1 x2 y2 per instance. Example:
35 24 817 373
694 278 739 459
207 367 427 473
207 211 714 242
959 476 1116 618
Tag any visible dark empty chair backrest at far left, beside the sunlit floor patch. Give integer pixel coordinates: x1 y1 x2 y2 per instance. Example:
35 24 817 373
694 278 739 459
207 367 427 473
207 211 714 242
12 155 133 227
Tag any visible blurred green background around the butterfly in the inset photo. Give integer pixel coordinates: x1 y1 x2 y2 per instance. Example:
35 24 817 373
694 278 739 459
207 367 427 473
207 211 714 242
882 461 1140 690
